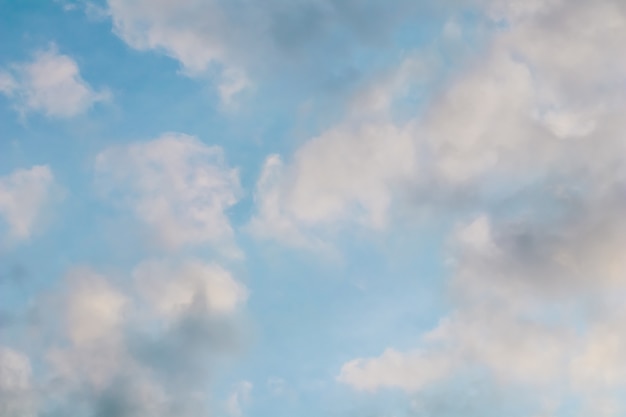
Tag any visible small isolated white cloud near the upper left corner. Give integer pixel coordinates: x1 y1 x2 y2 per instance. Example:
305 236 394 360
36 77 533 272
0 45 111 118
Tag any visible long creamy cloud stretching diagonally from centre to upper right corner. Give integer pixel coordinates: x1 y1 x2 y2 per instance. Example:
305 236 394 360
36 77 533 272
251 2 625 247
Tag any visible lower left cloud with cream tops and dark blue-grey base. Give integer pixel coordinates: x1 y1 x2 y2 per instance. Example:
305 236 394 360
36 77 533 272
37 261 247 417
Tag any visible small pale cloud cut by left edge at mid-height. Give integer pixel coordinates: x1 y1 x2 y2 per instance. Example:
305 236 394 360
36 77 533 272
0 165 55 240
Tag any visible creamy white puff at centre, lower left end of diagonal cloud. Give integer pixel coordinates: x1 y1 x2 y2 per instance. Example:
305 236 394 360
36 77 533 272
250 123 416 246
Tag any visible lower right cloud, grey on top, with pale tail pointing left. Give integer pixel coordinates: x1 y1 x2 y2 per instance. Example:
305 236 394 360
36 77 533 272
338 205 626 402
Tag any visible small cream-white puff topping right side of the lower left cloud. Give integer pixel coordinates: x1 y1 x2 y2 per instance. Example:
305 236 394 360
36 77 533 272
133 260 248 318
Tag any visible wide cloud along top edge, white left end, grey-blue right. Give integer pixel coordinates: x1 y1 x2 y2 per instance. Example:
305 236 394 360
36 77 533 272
108 0 412 70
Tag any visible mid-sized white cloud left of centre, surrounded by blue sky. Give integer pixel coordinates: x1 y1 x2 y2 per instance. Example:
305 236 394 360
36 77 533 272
95 133 241 255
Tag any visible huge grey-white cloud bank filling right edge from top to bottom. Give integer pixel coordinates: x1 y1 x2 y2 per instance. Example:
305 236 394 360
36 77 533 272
339 0 626 416
